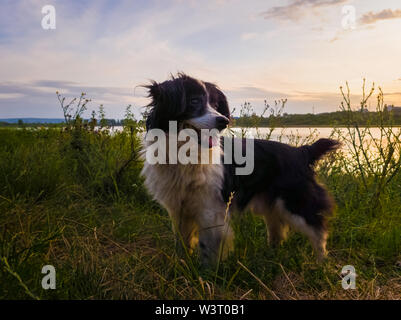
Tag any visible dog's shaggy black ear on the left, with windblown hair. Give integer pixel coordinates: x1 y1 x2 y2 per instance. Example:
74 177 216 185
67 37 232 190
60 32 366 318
144 78 185 131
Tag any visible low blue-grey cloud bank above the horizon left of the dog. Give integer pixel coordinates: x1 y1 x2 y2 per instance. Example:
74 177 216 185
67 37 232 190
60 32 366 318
0 80 147 118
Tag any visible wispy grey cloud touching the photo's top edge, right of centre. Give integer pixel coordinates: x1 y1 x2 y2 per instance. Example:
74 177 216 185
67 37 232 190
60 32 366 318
261 0 347 21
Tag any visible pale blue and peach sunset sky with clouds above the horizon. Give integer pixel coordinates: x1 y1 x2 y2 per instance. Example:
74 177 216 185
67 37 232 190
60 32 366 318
0 0 401 119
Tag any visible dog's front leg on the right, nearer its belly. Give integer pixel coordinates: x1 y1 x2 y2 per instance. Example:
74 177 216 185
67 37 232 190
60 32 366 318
198 209 232 265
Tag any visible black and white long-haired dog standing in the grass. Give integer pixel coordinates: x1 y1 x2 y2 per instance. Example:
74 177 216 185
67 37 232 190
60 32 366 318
142 73 339 263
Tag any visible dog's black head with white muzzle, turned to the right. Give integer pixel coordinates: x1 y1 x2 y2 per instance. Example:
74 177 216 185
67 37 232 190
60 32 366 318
145 73 230 146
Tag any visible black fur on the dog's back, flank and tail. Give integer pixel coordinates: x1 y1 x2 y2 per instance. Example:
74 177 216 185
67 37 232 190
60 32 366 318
223 139 339 229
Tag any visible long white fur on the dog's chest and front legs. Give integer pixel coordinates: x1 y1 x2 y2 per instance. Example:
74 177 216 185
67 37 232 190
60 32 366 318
142 141 231 261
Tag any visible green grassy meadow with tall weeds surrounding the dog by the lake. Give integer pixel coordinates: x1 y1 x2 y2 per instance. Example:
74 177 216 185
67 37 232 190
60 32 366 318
0 83 401 299
